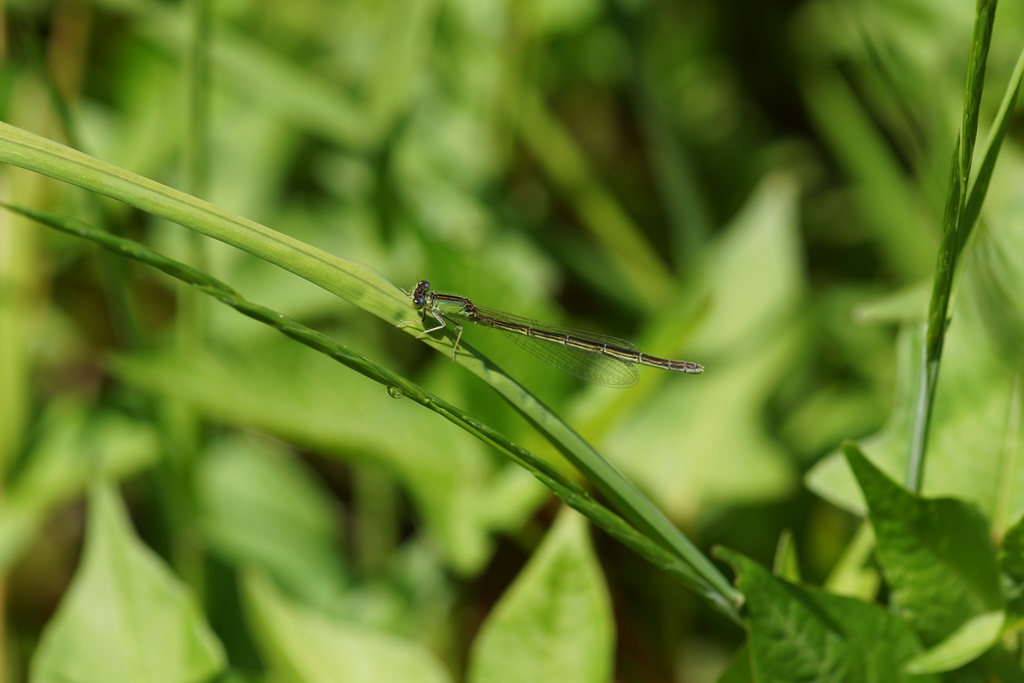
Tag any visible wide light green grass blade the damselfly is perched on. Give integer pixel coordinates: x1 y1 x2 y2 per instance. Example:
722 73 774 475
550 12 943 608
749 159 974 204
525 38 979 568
0 122 739 610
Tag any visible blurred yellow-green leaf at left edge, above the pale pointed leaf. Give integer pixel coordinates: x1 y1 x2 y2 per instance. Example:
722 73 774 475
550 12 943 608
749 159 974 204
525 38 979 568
0 400 158 567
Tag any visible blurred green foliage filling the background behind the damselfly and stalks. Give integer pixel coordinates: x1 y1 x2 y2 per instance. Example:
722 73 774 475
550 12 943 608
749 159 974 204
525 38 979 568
0 0 1024 681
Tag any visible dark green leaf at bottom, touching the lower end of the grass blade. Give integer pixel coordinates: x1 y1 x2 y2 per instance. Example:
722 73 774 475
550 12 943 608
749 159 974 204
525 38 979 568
718 550 935 683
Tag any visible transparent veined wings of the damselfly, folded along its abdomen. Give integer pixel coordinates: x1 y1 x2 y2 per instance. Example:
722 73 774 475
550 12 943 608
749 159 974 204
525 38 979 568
471 306 640 387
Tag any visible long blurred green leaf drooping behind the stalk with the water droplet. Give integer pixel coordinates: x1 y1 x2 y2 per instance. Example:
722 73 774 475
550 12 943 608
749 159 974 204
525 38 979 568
114 344 489 572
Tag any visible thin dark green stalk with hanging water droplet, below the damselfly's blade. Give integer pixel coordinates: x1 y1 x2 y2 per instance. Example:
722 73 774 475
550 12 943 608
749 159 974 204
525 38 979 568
4 200 742 623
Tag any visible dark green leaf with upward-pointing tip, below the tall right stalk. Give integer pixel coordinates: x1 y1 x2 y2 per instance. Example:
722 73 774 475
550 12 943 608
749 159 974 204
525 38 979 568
843 443 1002 643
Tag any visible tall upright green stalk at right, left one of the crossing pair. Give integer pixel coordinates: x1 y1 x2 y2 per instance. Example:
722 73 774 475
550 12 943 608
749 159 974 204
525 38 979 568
906 0 997 493
